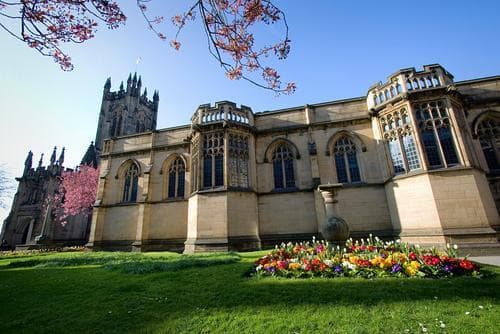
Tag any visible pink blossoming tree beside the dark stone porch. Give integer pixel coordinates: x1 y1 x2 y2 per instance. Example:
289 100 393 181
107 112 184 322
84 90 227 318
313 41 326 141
51 165 99 224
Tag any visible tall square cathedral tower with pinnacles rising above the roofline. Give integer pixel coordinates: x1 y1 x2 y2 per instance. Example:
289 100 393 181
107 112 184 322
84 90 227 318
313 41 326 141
95 73 160 159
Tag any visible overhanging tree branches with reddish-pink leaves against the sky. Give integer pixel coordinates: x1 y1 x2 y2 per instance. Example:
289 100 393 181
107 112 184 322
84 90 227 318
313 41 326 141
0 0 296 94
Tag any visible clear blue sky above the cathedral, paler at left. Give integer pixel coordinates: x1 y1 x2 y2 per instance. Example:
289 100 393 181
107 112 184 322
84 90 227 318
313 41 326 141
0 0 500 218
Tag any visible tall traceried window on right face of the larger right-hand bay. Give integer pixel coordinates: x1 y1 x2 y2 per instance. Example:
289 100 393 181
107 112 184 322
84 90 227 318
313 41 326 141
414 101 459 168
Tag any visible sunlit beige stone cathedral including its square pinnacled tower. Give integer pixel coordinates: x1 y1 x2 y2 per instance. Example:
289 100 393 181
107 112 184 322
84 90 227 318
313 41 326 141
2 64 500 253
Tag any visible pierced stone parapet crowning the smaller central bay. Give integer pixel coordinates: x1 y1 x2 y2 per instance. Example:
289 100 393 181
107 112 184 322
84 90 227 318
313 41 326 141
191 101 254 126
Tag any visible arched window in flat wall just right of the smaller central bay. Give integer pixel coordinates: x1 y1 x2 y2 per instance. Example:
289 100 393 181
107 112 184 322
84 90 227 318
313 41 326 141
272 143 295 190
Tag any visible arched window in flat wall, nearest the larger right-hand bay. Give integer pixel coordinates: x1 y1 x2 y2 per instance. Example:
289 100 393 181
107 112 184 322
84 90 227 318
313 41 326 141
333 136 361 183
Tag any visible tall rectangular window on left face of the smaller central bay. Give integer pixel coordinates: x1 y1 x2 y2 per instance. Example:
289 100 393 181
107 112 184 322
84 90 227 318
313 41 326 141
203 132 224 189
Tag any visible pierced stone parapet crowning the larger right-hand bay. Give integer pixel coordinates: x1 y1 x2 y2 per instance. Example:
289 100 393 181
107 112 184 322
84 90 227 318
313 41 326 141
366 64 453 110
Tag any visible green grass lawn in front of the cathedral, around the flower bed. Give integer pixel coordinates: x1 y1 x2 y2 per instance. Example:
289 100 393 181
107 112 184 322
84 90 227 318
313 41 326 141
0 252 500 334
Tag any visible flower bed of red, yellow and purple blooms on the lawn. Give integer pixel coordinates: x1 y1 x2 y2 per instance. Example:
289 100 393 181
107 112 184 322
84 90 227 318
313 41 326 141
255 235 480 278
